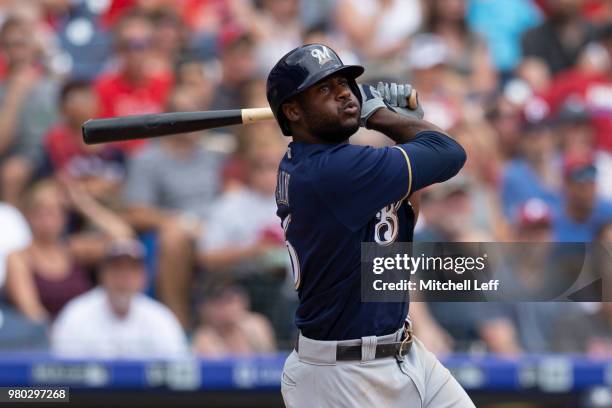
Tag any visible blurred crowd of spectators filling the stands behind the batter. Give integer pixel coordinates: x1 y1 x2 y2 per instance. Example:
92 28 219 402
0 0 612 357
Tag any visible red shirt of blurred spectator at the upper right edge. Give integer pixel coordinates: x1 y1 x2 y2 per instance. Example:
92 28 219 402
544 70 612 152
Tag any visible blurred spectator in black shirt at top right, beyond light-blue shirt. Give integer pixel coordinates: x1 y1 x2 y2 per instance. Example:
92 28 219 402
522 0 595 75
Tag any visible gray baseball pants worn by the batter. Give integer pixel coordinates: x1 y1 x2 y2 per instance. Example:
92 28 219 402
281 330 475 408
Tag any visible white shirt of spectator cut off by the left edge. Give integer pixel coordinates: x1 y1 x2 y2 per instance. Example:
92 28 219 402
0 203 32 288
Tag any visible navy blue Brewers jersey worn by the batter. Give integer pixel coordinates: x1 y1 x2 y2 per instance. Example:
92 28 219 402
276 131 465 340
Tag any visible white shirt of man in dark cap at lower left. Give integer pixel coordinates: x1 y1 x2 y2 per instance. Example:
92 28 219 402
51 287 188 358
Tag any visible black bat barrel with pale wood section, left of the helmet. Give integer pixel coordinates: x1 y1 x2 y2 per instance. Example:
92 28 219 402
82 108 274 144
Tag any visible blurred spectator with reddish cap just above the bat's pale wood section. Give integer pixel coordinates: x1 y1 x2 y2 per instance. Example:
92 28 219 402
210 25 256 109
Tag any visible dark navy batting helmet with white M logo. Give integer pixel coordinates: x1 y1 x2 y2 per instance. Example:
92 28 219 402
266 44 364 136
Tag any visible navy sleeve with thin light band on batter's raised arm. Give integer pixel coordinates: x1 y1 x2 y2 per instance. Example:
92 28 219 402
313 131 465 231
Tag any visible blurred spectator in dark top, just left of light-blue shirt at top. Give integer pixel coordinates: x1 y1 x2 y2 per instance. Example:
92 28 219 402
423 0 497 94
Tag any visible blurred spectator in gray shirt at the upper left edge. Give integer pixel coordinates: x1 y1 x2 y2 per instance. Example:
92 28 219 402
0 18 57 205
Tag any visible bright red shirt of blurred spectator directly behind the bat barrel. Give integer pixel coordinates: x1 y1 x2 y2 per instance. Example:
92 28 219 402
95 73 173 153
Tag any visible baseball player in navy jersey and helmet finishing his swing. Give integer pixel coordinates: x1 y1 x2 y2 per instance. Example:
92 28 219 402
267 44 474 408
